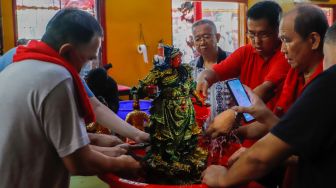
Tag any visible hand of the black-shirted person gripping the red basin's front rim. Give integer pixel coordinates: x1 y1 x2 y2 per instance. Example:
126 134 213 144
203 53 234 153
202 165 227 187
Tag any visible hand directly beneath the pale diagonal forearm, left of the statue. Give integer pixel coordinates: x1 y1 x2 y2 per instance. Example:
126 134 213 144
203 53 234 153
89 133 124 147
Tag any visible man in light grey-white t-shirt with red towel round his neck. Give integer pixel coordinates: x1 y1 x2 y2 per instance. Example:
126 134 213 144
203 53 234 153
0 9 140 187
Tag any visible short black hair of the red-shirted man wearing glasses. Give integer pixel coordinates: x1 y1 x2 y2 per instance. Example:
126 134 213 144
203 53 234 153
247 1 282 30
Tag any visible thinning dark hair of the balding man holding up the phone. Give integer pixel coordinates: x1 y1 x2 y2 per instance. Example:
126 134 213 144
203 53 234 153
292 4 329 43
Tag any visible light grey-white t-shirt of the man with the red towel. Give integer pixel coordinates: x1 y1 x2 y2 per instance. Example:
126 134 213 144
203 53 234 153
0 60 88 187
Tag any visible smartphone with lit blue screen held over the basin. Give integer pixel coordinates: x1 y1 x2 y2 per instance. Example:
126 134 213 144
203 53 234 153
226 78 254 123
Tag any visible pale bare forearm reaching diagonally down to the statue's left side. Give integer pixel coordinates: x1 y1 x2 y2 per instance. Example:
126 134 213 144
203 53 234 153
90 97 149 142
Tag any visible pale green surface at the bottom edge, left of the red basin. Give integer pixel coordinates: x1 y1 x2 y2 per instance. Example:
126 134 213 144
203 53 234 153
70 176 109 188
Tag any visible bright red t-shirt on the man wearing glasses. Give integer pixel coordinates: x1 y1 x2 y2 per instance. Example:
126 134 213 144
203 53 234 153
213 45 290 110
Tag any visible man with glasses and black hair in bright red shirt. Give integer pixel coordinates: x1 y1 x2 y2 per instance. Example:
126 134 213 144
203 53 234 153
197 1 289 108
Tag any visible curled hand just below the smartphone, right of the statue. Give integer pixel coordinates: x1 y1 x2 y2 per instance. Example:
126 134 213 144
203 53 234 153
206 109 237 138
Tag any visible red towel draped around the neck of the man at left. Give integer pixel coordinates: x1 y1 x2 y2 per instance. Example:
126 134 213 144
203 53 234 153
13 40 95 123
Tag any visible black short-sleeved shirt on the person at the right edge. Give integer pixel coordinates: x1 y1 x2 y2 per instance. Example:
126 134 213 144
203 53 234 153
271 65 336 188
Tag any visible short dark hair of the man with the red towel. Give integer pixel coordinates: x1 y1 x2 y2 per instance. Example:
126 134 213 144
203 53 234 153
42 8 103 50
